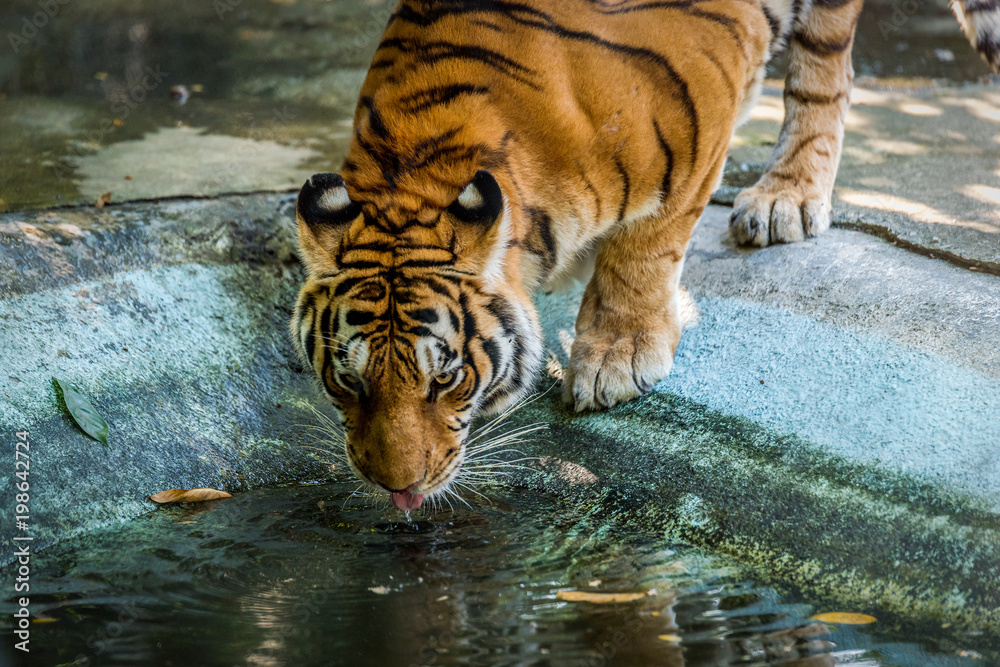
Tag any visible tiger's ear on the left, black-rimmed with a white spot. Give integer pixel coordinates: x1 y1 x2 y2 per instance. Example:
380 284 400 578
295 174 361 277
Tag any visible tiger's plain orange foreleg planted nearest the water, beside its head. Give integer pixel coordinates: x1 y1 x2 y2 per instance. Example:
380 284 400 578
565 207 703 412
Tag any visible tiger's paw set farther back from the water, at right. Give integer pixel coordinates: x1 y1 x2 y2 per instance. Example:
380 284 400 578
729 179 830 248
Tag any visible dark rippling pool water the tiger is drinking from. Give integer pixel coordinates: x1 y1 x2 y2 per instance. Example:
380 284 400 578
0 483 982 667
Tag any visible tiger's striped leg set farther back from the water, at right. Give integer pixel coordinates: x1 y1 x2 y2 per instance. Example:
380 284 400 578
729 0 862 247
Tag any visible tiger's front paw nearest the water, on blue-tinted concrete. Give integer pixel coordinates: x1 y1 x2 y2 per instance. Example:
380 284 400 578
564 327 680 412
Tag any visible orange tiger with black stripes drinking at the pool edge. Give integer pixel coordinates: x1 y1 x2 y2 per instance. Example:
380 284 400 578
291 0 1000 511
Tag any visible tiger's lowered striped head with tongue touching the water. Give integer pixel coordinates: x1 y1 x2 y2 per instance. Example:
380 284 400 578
291 125 542 510
